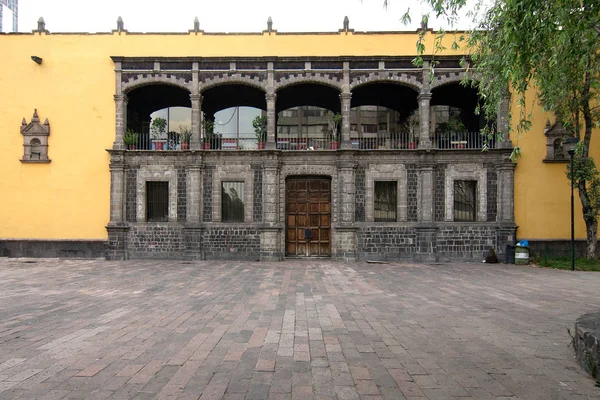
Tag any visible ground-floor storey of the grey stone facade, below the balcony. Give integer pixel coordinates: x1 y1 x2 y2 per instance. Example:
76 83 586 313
108 149 515 261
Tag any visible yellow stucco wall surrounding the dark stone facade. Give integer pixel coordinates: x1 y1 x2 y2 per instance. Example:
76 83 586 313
0 33 600 239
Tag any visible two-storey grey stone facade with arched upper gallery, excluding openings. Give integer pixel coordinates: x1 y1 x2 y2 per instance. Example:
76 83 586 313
107 57 516 261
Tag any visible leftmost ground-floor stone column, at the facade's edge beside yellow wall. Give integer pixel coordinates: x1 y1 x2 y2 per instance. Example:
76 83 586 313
106 151 129 260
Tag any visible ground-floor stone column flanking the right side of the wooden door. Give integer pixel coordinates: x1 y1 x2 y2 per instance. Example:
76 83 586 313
332 155 357 261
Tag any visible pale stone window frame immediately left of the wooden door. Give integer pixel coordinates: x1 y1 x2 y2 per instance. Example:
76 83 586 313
212 165 254 224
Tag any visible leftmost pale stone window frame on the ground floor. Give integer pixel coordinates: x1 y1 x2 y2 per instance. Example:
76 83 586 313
136 165 177 224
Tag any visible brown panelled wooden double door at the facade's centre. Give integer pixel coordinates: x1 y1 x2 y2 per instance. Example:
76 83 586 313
285 176 331 257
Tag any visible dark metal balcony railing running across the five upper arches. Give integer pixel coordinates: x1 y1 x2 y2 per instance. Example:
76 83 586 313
124 131 497 151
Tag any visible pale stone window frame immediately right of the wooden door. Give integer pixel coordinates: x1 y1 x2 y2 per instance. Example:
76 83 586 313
365 164 408 224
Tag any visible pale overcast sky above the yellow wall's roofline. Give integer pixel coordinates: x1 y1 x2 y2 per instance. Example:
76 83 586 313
4 0 464 32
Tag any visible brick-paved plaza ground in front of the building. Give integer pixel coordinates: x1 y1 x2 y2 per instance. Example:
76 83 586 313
0 259 600 400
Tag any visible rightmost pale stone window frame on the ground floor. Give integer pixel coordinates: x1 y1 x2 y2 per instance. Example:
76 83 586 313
444 164 487 224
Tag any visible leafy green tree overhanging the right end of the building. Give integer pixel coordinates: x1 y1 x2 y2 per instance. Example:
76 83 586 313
384 0 600 257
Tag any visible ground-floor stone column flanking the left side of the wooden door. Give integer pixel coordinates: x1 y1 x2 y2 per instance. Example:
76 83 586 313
260 157 283 261
